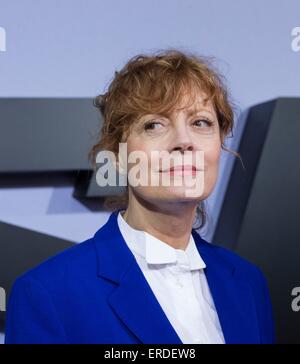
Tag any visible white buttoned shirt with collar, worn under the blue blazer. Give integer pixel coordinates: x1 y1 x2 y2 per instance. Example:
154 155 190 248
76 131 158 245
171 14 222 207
118 211 224 344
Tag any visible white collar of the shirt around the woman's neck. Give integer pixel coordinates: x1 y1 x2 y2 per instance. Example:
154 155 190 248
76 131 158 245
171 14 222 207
118 211 206 270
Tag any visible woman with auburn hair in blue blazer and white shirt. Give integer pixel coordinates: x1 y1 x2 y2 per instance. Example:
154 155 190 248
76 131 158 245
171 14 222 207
6 50 274 344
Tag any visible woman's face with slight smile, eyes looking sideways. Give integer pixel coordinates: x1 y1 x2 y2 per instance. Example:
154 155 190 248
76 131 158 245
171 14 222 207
120 92 221 203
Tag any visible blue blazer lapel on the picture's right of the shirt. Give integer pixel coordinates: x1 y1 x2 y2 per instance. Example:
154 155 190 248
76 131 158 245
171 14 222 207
192 230 260 344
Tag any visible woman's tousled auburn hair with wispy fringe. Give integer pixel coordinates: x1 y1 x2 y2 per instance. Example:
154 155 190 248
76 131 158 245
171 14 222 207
89 49 240 229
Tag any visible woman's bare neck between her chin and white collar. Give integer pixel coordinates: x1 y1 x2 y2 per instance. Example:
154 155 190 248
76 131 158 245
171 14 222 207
123 194 197 250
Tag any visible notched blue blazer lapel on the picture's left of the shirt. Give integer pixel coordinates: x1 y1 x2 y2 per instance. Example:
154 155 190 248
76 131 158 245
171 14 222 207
94 210 182 344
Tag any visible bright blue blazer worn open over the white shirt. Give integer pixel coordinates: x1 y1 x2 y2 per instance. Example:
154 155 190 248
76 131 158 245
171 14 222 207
5 210 274 344
